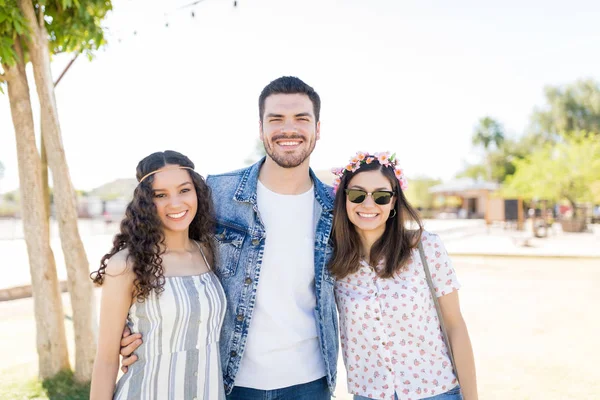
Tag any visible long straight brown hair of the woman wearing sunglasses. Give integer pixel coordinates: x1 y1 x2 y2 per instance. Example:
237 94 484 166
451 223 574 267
329 160 423 279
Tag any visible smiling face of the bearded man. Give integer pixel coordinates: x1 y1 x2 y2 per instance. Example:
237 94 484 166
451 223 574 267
260 94 320 168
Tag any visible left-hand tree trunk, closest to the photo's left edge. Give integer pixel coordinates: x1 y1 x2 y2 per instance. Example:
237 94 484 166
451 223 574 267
3 42 70 379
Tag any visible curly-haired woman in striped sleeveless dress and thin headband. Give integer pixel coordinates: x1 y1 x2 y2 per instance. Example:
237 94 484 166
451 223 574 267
90 151 225 400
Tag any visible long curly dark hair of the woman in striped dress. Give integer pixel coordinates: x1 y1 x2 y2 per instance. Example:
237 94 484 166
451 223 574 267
90 150 215 301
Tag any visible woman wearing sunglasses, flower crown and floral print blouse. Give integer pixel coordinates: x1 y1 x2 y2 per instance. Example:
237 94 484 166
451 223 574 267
330 153 477 400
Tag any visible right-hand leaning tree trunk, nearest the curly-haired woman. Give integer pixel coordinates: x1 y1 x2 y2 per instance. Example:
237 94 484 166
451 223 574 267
18 0 96 382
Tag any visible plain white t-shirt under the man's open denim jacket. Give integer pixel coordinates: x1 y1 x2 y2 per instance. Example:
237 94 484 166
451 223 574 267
235 181 325 390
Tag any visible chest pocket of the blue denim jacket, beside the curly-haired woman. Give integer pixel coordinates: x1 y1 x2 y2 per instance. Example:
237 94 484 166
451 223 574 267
215 223 246 277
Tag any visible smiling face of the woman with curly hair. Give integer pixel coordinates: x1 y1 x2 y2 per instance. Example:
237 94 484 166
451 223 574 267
152 165 198 232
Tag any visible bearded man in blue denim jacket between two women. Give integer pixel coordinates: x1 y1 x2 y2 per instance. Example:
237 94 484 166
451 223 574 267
121 77 338 400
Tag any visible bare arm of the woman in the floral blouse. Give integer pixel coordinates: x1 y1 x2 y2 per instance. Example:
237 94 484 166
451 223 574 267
438 290 479 400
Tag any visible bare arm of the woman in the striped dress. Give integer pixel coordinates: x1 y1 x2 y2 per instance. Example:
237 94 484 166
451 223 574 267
90 252 134 400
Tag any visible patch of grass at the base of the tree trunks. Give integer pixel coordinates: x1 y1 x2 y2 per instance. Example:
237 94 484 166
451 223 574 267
0 371 90 400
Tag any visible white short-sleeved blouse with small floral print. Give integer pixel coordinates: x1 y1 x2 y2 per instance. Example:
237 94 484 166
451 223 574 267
335 232 460 400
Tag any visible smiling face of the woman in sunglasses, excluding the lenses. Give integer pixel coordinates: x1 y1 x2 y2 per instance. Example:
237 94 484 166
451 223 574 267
346 170 396 238
